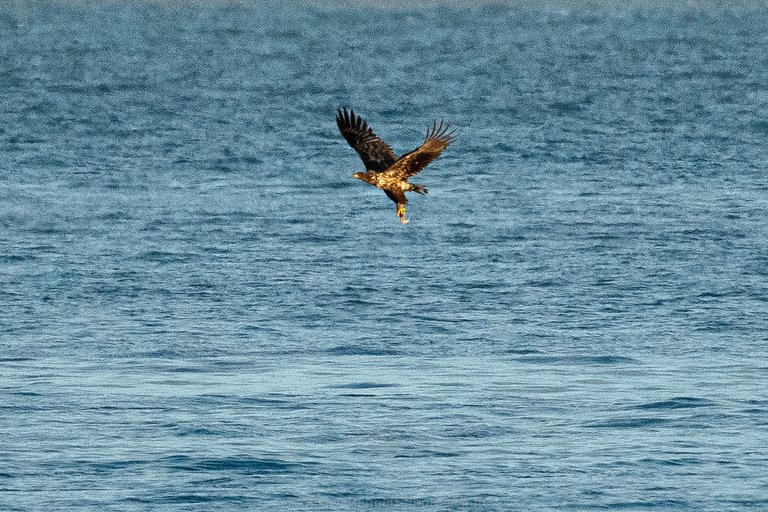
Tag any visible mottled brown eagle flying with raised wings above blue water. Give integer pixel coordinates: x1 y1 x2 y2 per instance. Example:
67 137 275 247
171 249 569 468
336 108 456 224
